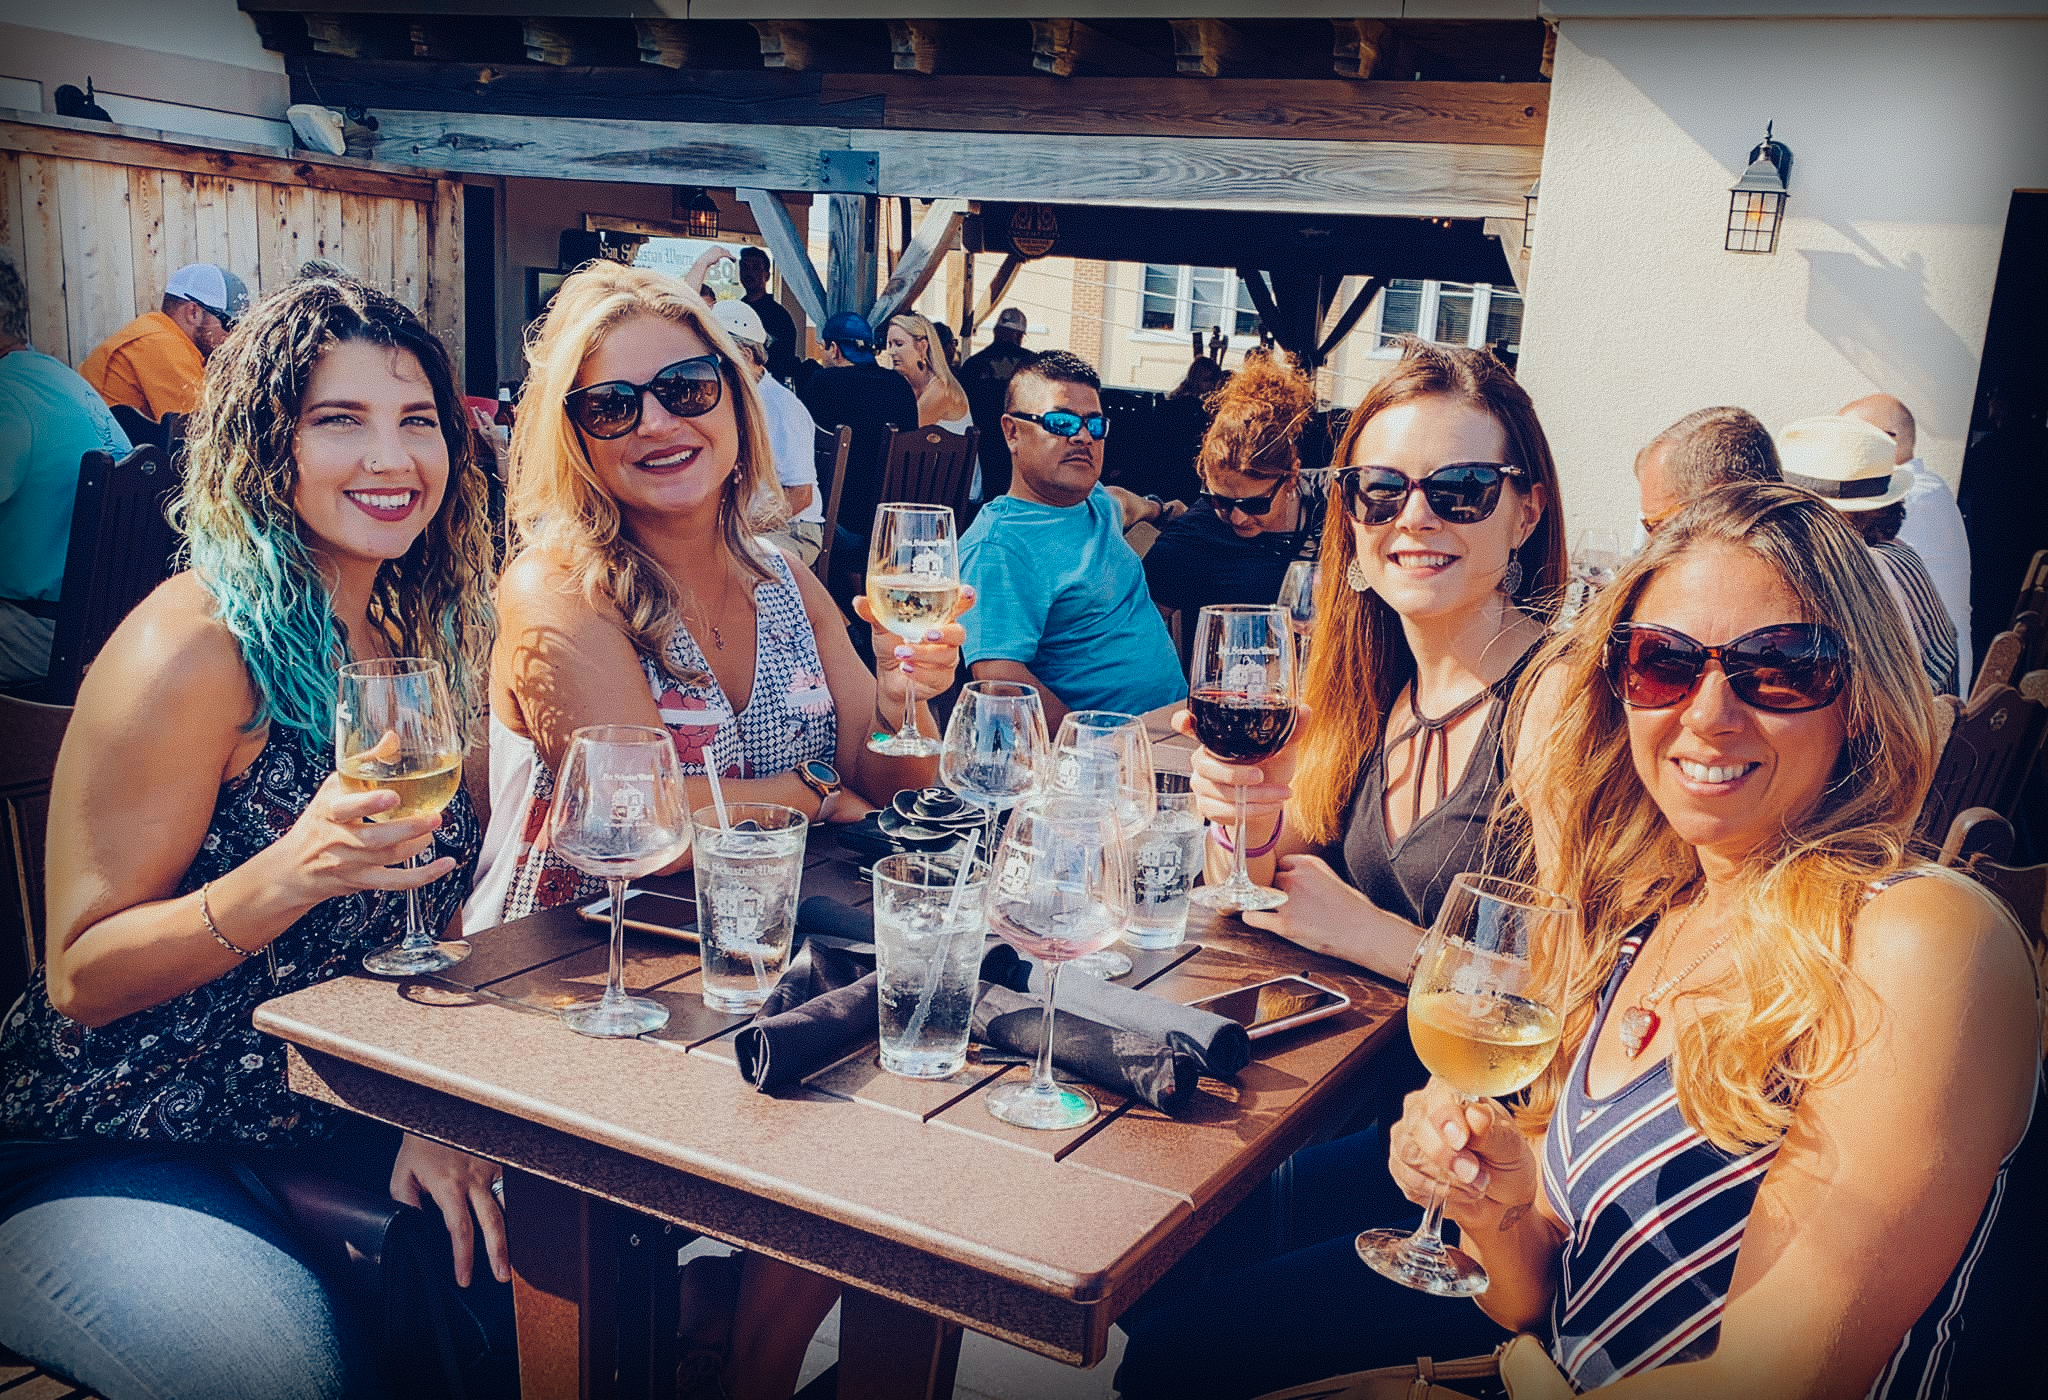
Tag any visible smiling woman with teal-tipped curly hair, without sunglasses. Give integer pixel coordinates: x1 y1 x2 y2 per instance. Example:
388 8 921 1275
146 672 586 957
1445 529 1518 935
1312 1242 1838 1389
0 278 514 1398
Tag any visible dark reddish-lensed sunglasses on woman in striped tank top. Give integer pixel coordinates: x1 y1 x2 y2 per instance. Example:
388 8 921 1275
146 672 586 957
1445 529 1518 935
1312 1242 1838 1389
1606 622 1849 714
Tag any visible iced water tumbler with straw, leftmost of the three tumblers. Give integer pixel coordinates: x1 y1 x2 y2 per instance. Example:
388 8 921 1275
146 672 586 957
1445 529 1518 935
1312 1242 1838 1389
696 802 811 1015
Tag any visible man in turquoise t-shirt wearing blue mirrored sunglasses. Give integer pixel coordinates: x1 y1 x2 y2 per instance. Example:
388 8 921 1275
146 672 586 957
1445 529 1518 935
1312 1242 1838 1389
961 350 1188 731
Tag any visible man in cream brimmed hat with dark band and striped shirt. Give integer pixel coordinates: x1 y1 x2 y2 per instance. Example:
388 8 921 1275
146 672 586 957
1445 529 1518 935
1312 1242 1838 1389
1778 418 1962 696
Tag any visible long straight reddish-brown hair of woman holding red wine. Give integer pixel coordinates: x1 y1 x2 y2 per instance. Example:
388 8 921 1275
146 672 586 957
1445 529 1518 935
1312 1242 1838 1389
1294 340 1565 845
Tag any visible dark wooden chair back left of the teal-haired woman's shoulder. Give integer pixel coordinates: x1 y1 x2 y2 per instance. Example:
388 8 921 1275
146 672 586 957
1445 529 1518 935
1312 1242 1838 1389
41 446 178 704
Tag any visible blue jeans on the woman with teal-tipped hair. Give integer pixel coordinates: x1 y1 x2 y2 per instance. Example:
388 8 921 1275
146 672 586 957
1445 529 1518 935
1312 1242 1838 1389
0 1130 510 1400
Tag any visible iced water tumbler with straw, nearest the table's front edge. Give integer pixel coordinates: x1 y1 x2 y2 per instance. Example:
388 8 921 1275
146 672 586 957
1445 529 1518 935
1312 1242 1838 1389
874 851 989 1079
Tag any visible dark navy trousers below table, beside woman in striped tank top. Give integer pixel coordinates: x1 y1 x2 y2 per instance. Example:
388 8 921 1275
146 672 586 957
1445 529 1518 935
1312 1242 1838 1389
1116 1128 1507 1400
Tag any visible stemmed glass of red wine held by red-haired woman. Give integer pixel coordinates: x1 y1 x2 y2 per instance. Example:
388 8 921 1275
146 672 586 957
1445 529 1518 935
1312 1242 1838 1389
1188 604 1294 913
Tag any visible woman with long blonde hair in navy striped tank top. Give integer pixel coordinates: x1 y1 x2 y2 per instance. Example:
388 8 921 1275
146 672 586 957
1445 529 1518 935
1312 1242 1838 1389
1389 483 2040 1400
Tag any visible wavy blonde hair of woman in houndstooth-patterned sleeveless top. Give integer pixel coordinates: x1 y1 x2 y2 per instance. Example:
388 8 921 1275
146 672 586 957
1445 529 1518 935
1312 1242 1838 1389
508 262 780 671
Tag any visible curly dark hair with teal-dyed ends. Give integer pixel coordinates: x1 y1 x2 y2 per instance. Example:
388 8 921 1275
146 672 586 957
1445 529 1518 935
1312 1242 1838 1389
172 276 494 735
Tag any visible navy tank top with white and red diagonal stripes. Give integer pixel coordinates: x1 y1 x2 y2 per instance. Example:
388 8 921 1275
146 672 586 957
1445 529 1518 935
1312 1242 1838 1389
1542 908 2023 1400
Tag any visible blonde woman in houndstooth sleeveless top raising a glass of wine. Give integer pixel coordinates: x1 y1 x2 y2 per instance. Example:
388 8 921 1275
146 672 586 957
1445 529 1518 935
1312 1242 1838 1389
467 262 967 1400
